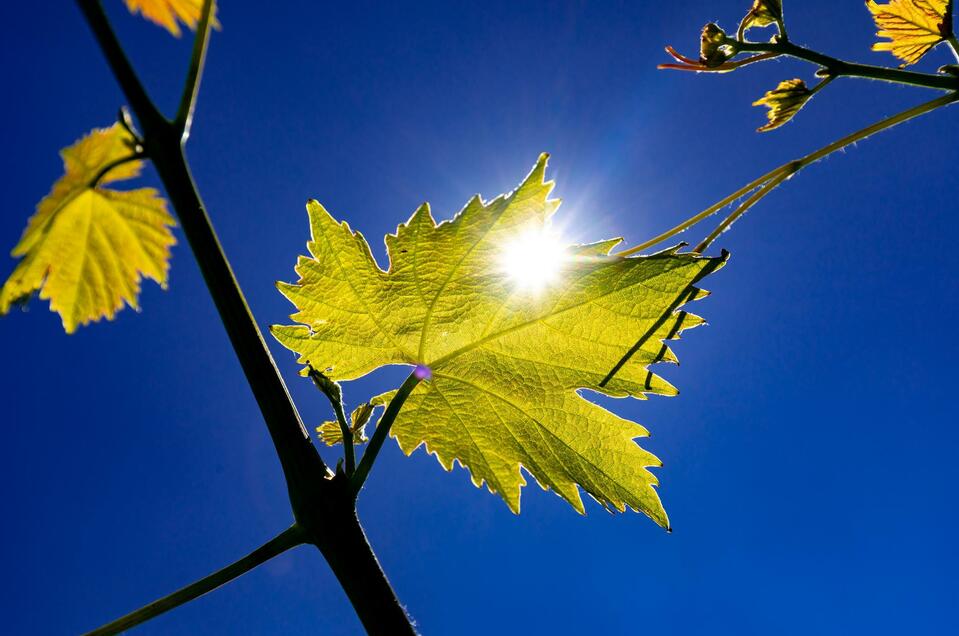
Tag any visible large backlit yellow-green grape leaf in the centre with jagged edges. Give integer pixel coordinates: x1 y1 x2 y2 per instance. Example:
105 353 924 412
271 155 725 527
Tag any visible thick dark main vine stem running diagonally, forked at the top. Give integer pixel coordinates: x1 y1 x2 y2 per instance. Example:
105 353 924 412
76 0 413 634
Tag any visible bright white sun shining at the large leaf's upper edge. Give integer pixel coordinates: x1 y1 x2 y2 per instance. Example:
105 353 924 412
499 227 569 294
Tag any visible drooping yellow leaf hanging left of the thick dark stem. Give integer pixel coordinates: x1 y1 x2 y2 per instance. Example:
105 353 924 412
0 124 176 333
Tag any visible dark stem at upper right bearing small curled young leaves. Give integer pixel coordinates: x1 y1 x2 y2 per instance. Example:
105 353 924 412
736 42 959 91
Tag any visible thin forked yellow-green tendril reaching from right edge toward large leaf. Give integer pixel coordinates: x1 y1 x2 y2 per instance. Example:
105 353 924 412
616 92 959 256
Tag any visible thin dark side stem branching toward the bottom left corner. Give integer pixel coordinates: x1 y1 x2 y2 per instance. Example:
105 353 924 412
87 525 306 636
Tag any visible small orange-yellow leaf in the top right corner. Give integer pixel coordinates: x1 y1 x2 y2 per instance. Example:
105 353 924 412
866 0 952 68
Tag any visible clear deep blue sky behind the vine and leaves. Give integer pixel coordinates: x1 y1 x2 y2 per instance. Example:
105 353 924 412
0 0 959 635
